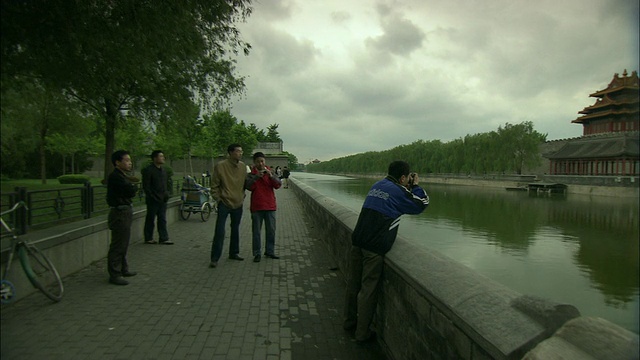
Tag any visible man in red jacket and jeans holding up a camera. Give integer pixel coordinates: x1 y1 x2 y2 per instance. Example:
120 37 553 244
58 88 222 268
244 152 282 262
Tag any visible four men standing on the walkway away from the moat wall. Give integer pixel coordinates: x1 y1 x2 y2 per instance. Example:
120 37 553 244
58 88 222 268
107 144 290 285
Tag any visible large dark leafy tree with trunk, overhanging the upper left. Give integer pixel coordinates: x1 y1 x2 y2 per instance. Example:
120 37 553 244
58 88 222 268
0 0 251 178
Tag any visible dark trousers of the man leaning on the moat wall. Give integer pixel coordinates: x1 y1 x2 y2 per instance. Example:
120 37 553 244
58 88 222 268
343 246 384 341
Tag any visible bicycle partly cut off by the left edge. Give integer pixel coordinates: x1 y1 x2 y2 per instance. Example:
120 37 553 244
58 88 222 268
0 201 64 304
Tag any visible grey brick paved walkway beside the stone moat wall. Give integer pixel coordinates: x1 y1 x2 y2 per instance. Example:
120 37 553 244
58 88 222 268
0 189 384 360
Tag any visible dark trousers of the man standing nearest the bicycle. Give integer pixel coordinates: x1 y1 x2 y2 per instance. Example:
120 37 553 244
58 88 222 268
107 205 133 278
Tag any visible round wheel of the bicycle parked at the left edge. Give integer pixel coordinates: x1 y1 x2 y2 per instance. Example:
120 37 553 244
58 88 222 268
18 245 64 302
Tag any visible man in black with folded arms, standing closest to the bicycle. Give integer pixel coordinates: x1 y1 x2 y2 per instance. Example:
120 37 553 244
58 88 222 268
107 150 140 285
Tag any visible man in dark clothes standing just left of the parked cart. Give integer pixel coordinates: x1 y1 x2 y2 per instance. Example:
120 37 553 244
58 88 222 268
142 150 173 245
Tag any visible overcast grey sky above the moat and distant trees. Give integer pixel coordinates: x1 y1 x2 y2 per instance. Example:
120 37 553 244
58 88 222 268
232 0 640 163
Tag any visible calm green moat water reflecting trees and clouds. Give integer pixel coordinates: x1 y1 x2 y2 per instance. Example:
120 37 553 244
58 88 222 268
291 172 640 333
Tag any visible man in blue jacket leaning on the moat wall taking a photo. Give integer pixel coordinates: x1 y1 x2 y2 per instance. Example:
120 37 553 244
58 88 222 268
343 161 429 343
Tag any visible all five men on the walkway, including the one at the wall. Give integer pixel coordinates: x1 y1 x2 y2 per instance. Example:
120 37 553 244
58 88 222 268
107 144 429 343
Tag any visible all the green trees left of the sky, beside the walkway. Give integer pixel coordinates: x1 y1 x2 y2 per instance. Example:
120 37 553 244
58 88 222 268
0 0 288 181
